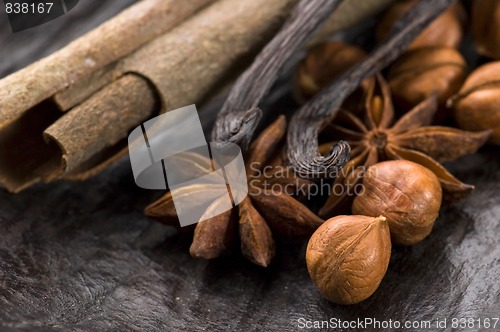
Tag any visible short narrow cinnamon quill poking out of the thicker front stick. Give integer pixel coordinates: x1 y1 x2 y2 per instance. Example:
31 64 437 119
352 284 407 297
43 74 157 181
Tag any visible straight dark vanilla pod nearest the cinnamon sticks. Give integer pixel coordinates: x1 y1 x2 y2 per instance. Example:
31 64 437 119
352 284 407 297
212 0 343 148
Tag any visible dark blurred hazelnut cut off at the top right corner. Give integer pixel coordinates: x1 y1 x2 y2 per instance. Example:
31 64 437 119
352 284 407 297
472 0 500 59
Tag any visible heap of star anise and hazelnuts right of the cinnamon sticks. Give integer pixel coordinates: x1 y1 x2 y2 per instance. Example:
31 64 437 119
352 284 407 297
146 0 500 304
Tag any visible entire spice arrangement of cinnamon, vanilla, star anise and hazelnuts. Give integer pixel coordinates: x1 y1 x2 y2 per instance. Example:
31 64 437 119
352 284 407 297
0 0 500 304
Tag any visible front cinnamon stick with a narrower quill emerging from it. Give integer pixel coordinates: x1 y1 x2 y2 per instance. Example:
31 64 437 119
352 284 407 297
0 0 296 191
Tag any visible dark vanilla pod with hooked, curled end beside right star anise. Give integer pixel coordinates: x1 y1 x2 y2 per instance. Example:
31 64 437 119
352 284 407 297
287 0 456 179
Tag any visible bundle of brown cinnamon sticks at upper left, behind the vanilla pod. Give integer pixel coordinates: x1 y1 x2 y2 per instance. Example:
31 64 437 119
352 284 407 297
0 0 392 192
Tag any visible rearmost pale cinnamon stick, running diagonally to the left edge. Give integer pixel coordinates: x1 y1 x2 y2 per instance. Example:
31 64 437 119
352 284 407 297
0 0 214 128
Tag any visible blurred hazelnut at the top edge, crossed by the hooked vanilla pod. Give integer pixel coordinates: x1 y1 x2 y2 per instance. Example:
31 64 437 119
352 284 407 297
375 0 466 49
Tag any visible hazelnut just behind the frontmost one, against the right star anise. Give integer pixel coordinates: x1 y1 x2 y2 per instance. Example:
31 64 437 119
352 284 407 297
352 160 442 245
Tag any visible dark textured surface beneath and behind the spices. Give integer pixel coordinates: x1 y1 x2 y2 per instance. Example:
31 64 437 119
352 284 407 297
0 0 500 331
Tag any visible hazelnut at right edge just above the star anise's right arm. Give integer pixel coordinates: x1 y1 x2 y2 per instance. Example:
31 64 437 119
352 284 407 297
449 61 500 145
